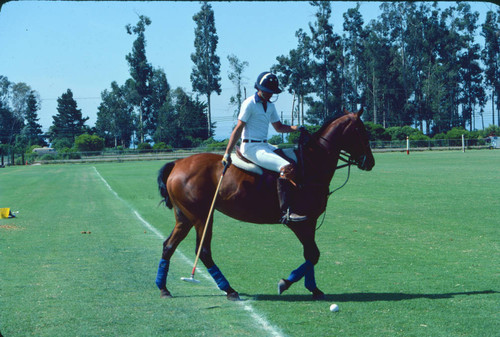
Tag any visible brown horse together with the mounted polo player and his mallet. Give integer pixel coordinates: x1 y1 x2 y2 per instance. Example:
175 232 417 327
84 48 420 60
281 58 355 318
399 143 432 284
155 72 375 300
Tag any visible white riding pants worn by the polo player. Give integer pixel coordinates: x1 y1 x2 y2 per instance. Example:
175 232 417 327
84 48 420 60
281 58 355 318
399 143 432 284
241 143 290 172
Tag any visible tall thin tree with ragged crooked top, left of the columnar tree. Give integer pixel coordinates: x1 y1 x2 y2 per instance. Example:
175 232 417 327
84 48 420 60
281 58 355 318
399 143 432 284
125 15 153 143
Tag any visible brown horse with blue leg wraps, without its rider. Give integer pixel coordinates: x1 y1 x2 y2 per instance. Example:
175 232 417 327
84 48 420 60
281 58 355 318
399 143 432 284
156 110 375 300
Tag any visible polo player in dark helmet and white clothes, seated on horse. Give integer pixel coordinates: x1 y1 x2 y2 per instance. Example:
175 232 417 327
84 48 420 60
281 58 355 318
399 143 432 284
222 72 307 223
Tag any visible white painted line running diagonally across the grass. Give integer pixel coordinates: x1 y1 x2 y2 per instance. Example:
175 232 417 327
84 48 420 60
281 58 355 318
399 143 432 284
93 166 285 337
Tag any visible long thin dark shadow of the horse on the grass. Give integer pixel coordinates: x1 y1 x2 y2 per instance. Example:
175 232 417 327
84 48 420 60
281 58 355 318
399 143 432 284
246 290 499 302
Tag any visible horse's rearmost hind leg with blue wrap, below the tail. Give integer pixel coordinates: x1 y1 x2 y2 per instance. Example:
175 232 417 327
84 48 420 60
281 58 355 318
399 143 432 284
156 209 193 297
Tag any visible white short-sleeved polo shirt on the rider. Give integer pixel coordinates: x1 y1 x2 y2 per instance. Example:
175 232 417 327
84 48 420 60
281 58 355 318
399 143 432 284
238 93 280 140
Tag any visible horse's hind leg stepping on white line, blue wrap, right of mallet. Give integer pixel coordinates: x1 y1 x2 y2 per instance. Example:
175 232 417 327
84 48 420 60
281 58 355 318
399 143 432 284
196 217 240 301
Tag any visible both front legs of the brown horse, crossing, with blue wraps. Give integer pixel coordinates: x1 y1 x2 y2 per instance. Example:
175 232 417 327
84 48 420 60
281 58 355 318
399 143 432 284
278 222 325 299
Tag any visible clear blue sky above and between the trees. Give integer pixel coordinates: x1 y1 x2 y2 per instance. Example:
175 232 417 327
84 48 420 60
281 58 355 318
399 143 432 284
0 1 496 139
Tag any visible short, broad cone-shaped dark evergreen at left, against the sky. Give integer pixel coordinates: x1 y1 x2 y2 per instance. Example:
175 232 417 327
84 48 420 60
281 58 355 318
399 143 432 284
49 89 89 145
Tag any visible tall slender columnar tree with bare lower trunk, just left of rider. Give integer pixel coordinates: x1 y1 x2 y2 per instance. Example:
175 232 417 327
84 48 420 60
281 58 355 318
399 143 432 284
191 1 221 136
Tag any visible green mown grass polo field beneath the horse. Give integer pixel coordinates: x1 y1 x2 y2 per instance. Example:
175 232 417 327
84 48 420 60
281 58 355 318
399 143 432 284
0 150 500 337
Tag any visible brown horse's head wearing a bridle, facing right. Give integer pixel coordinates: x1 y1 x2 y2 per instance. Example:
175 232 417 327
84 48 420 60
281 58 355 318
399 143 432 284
317 109 375 171
